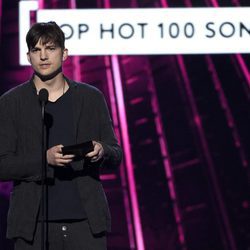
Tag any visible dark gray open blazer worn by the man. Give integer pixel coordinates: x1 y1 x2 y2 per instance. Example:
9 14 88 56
0 78 122 241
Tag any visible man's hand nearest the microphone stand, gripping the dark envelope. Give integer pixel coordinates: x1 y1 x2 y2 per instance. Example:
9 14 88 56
47 145 75 167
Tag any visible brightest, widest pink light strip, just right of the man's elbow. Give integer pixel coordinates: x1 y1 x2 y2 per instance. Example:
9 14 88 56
111 55 145 250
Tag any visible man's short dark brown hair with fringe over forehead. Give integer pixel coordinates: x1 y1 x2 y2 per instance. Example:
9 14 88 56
26 22 65 51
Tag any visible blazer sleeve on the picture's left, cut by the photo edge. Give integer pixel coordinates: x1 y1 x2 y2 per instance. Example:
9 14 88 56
0 96 42 181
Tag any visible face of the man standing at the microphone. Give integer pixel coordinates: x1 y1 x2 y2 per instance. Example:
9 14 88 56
27 39 68 76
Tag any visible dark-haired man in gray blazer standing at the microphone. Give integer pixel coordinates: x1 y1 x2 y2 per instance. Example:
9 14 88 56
0 22 122 250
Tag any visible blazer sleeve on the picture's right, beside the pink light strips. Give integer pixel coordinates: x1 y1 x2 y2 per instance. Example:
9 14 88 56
97 93 122 168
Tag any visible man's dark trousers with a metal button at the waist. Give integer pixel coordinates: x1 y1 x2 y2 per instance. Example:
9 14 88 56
15 220 107 250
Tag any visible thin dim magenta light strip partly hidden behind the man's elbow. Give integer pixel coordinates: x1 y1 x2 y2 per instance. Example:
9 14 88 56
104 56 136 249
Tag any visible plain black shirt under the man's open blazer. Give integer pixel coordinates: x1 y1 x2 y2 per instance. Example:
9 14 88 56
45 89 86 220
